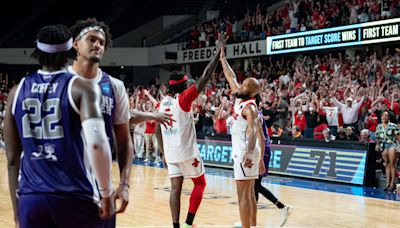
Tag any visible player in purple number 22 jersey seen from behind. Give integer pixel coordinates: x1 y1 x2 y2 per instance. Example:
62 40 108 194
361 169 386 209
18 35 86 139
4 25 115 228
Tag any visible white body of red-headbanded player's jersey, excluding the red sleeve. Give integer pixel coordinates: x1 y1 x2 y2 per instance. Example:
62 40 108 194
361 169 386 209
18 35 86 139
160 95 199 162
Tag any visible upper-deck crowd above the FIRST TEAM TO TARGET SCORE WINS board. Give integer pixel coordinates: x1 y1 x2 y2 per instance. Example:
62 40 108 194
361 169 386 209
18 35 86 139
183 0 400 49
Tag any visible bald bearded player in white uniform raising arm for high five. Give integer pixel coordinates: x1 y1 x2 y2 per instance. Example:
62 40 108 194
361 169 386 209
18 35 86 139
220 50 265 228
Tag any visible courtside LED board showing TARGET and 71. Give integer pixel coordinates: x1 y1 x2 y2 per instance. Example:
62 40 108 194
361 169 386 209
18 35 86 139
197 137 367 185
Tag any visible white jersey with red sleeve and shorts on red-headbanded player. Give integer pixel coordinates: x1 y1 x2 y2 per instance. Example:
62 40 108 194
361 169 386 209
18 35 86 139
160 85 204 178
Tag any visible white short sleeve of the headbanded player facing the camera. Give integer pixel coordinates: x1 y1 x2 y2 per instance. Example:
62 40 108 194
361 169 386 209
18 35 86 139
110 77 130 125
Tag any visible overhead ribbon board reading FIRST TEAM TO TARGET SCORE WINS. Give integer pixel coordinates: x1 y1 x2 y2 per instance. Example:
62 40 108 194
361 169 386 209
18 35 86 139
266 18 400 55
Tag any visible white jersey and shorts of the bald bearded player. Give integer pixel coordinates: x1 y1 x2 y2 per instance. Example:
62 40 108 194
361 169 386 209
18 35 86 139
231 98 261 180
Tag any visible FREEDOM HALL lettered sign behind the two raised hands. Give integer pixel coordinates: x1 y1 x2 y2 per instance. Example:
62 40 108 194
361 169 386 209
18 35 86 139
178 40 267 64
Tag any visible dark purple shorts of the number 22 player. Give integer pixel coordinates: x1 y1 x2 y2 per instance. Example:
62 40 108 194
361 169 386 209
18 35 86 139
18 194 115 228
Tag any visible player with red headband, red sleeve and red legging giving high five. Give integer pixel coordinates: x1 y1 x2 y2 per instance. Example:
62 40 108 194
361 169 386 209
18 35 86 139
156 35 227 228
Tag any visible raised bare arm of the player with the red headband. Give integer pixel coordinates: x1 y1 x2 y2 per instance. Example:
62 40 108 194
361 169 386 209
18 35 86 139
196 34 228 92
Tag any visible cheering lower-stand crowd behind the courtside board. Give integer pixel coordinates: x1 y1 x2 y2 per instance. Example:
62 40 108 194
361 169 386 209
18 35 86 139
129 49 400 149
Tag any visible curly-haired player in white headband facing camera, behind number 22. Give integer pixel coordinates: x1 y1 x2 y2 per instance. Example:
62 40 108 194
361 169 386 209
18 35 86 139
68 18 171 227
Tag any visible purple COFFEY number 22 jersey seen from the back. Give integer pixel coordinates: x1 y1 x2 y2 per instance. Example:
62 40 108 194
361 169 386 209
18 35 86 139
12 70 98 200
